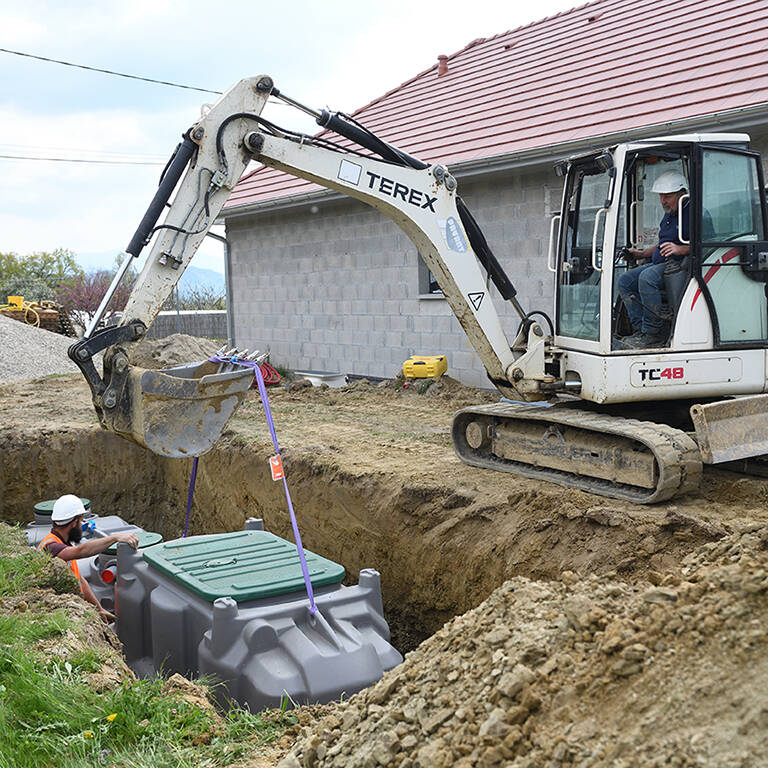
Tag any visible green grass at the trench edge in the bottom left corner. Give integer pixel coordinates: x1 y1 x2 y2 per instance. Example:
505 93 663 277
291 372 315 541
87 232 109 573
0 524 295 768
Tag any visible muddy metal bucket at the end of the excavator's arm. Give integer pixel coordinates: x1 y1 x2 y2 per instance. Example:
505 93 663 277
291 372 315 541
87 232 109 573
105 361 253 458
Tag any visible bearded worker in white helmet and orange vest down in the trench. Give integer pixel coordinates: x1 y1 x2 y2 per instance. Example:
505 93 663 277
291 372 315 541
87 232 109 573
39 493 139 624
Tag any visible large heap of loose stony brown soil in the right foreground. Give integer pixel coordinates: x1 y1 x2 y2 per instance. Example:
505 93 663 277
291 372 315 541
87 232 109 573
280 526 768 768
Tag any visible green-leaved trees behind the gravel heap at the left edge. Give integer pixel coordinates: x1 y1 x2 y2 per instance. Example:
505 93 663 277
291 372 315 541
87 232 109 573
0 248 83 303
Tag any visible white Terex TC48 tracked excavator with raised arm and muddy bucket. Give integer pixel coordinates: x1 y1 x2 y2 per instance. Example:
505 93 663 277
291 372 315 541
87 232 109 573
69 76 768 503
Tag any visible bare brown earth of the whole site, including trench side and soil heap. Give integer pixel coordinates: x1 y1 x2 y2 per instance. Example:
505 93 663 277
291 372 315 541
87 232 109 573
0 332 768 768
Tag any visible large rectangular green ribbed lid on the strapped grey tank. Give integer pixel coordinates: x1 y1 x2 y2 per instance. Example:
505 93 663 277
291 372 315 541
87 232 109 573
143 531 345 602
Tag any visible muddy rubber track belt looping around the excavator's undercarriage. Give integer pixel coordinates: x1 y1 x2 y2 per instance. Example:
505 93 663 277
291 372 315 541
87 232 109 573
453 403 702 504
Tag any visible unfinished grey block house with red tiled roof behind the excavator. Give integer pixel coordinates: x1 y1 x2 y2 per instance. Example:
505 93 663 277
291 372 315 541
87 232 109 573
222 0 768 386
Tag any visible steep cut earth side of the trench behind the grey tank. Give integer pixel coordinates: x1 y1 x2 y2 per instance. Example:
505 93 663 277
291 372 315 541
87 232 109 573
0 414 765 652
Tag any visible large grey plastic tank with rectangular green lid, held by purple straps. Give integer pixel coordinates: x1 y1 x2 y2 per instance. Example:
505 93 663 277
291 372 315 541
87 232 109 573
117 521 402 711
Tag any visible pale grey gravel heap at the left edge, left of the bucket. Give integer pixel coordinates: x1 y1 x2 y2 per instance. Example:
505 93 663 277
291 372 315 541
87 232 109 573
0 315 79 383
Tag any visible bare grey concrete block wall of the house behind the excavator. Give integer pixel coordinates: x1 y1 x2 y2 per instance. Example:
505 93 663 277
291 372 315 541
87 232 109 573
227 168 560 387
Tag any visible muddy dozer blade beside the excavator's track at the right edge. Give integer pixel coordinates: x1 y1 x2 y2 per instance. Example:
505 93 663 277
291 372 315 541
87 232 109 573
691 395 768 464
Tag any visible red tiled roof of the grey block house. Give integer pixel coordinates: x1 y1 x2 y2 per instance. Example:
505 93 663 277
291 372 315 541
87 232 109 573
226 0 768 209
